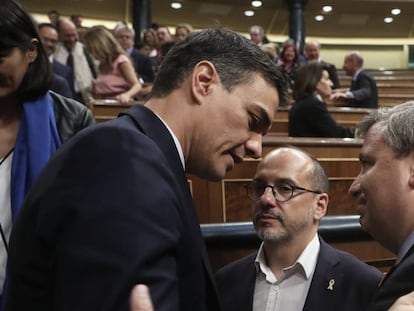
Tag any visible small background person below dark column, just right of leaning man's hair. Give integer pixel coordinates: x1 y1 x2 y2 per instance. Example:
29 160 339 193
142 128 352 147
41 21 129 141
276 40 299 90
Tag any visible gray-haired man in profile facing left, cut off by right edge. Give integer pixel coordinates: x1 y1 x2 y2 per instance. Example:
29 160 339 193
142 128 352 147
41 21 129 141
349 102 414 311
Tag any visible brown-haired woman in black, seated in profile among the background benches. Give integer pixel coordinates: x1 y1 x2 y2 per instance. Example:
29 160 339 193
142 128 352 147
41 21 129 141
289 62 354 137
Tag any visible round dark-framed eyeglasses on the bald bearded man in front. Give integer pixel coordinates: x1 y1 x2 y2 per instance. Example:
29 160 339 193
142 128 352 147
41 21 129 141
245 180 322 202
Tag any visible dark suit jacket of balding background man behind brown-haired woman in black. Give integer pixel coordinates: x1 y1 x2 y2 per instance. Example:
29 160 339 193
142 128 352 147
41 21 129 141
350 70 378 108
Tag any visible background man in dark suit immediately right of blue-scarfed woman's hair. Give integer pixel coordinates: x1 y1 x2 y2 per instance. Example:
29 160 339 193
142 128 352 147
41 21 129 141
38 23 74 98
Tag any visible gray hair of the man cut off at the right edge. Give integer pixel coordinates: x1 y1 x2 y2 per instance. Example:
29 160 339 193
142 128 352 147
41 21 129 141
358 101 414 157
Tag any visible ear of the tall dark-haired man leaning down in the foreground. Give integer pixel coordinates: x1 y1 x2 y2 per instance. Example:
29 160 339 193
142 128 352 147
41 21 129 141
191 61 219 103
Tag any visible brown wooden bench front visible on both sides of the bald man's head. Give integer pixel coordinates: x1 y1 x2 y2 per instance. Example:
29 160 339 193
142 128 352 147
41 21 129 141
189 151 360 223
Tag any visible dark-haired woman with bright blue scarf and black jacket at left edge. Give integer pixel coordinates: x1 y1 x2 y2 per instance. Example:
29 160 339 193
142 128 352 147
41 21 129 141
0 0 94 310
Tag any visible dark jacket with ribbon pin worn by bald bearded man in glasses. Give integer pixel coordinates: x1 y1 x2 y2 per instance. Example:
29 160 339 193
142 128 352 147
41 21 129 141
216 239 382 311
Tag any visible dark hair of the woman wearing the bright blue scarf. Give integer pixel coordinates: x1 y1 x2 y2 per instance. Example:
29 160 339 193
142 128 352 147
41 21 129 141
0 0 52 102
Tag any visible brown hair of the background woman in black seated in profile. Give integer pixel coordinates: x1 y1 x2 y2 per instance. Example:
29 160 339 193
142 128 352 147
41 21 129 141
293 61 327 100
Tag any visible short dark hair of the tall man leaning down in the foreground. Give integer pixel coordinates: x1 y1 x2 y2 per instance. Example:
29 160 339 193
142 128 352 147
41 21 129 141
151 28 286 98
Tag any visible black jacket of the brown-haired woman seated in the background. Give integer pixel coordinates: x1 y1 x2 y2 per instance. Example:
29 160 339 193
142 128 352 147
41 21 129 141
289 96 354 138
